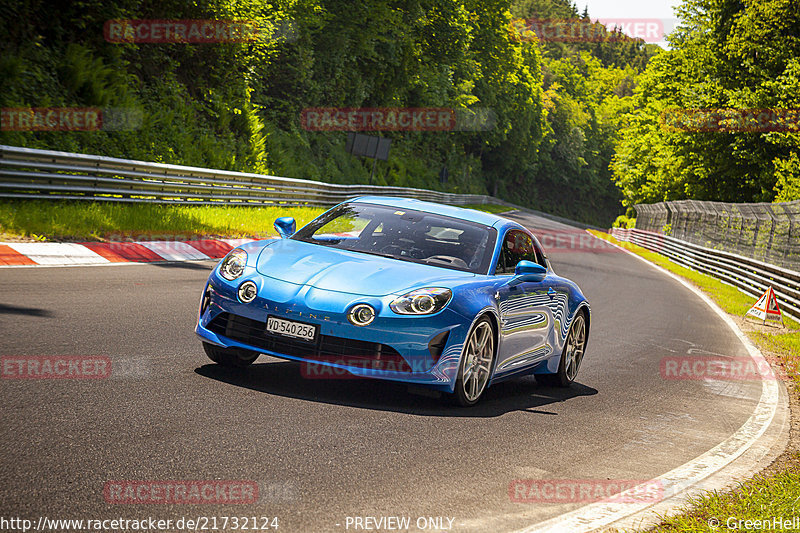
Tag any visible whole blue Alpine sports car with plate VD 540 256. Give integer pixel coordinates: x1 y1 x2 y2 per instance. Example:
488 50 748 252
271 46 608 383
196 197 590 406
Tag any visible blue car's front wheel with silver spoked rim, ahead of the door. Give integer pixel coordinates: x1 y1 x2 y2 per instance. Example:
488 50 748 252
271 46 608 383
451 317 495 407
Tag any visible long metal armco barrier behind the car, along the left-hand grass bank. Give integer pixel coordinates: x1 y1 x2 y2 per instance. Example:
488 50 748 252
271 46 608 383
0 145 506 207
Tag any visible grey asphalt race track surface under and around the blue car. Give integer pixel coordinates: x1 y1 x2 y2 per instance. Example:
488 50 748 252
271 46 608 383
0 213 761 532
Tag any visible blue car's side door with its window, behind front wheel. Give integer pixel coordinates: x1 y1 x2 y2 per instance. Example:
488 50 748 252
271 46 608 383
495 229 555 374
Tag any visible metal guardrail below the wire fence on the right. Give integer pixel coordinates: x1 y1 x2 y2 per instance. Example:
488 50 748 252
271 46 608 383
611 228 800 320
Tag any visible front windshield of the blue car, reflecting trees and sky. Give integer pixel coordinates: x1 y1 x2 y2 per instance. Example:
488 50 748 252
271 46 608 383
292 203 497 274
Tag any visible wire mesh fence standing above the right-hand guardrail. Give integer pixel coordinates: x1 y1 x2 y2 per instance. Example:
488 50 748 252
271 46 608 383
634 200 800 270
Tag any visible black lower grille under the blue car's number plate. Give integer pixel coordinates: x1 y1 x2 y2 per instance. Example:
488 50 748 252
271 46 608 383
208 313 411 372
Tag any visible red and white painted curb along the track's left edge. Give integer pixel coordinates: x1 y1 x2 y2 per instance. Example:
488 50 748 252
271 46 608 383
0 239 253 268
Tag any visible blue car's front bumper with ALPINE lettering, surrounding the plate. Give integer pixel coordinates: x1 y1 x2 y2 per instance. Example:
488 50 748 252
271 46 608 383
195 269 470 392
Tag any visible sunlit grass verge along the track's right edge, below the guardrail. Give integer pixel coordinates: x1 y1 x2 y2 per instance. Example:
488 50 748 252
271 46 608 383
590 231 800 532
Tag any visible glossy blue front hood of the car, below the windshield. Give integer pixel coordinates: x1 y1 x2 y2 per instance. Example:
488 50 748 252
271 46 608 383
256 239 475 296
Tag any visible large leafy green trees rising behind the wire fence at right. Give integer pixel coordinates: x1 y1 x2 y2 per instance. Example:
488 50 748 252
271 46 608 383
613 0 800 205
